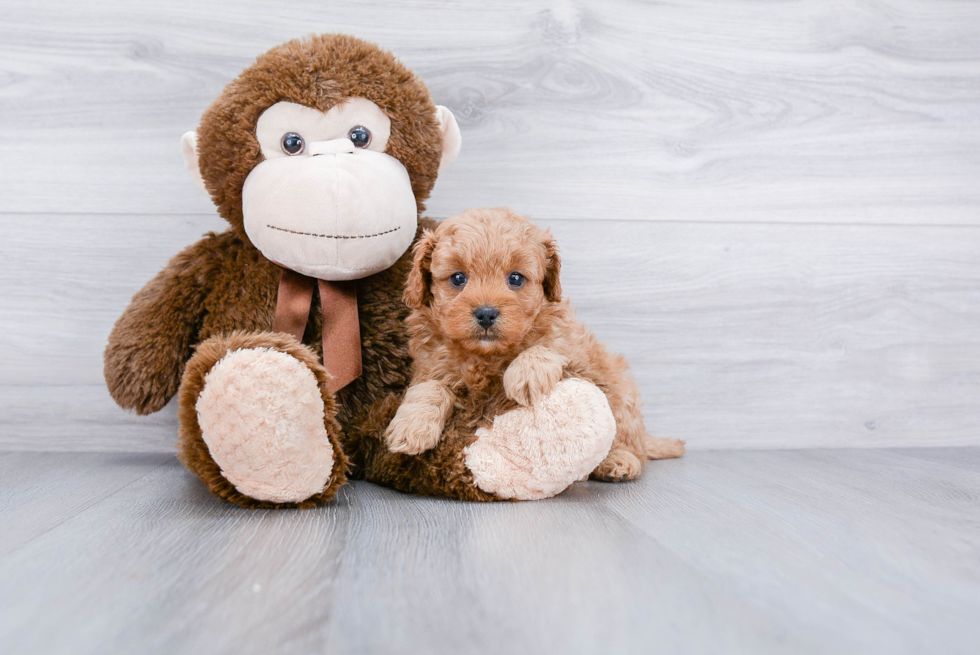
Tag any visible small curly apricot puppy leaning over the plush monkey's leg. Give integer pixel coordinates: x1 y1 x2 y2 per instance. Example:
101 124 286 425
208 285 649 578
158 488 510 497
385 208 684 481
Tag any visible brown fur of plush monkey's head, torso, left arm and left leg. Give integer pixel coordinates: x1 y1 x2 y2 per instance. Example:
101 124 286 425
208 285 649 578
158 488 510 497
105 35 452 507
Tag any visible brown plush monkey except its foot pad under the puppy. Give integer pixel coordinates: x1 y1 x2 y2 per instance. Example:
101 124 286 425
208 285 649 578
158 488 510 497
105 35 612 507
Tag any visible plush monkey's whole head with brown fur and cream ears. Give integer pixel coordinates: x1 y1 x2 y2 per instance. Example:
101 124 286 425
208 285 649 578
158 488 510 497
181 34 460 280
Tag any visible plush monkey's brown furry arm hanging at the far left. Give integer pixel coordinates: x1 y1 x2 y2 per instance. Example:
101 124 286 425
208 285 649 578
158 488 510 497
104 235 218 414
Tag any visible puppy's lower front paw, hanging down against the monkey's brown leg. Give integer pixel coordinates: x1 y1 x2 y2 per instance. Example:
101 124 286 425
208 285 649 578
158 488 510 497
385 380 456 455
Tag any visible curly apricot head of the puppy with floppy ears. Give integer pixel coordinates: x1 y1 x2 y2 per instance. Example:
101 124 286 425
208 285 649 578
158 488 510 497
405 208 561 354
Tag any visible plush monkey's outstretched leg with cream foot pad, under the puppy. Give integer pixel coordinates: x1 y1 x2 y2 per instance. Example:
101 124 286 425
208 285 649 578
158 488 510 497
347 379 616 501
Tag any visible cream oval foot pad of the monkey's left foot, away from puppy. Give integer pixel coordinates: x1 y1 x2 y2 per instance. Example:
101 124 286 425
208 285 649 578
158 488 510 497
196 348 334 503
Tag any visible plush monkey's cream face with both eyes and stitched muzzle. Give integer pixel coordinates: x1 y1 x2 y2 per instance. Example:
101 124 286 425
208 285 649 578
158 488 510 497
242 98 417 280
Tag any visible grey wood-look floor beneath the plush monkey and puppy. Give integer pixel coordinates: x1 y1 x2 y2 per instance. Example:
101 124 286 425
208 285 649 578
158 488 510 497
0 448 980 653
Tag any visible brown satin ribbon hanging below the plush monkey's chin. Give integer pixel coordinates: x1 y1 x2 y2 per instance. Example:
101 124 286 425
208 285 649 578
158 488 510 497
272 268 361 392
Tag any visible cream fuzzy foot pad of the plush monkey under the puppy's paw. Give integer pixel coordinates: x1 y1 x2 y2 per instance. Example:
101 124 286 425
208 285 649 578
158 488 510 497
463 379 616 500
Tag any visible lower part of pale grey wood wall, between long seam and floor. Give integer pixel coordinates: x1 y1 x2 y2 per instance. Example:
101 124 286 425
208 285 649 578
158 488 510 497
0 215 980 451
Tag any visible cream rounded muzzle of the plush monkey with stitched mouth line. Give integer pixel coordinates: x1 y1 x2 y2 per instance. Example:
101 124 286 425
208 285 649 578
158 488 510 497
242 145 418 281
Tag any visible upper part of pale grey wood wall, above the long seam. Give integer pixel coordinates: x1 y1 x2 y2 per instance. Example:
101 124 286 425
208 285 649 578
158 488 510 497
0 0 980 225
